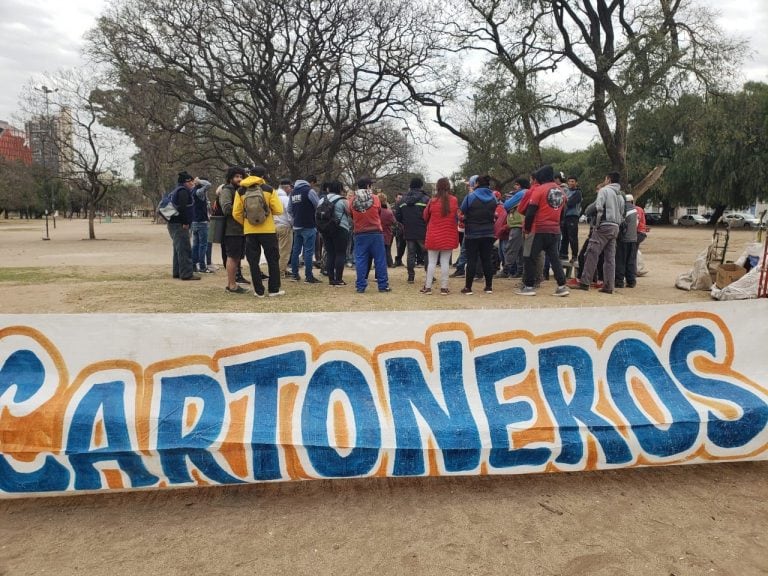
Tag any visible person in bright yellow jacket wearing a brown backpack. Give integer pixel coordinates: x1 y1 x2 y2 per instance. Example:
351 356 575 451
232 166 285 298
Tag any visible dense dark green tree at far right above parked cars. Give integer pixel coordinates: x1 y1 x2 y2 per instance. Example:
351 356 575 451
629 82 768 222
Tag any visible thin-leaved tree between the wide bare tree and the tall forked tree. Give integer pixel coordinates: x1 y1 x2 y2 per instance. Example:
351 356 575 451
414 0 590 171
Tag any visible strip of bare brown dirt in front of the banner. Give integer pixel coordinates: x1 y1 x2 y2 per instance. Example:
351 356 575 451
0 463 768 576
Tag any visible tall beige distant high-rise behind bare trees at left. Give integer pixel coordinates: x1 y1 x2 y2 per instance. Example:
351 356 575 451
26 108 72 176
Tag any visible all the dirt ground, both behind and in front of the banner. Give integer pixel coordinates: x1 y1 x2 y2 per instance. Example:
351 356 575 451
0 221 768 576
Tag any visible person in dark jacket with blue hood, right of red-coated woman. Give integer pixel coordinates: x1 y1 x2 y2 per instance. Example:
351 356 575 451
460 175 498 295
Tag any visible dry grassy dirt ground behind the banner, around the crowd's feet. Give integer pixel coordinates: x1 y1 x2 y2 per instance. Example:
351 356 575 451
0 221 753 313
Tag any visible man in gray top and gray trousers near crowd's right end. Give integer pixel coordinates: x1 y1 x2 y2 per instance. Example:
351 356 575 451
578 172 625 294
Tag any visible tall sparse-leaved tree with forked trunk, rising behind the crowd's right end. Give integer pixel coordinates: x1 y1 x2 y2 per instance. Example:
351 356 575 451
539 0 744 184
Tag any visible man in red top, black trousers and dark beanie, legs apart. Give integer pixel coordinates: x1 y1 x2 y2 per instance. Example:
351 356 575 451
516 165 570 296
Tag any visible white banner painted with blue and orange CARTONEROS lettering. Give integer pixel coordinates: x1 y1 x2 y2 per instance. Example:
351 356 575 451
0 300 768 496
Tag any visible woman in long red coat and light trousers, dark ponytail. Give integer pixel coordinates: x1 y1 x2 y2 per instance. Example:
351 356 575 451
421 178 459 296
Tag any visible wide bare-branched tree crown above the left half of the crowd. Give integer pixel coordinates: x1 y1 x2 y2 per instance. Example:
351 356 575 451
89 0 449 177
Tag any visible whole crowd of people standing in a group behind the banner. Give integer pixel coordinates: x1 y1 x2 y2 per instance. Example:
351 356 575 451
167 166 647 298
